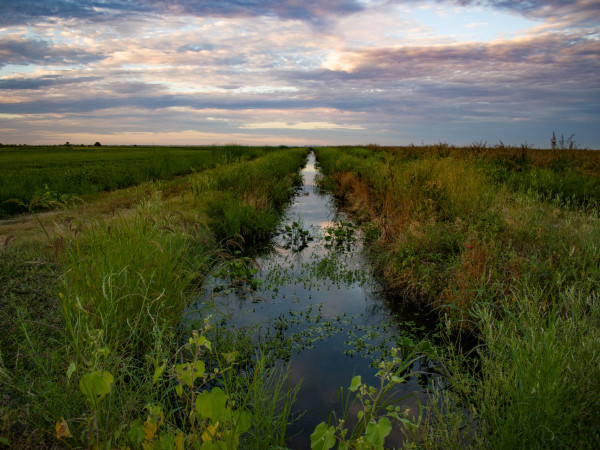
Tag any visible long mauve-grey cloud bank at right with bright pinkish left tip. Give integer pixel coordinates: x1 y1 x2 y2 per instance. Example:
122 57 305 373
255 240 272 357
314 34 600 86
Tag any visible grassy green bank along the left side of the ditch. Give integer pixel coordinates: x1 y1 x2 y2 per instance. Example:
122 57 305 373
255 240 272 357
0 149 306 448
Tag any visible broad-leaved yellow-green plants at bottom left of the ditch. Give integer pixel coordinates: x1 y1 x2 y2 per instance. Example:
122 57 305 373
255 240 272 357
56 320 252 450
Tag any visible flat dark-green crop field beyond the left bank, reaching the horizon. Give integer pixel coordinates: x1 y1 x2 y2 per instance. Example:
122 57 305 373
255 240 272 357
0 145 284 218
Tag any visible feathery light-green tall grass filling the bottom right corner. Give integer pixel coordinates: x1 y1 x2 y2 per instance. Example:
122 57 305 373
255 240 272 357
472 286 600 448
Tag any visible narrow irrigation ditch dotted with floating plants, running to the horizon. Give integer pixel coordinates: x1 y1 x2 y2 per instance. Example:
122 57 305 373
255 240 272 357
186 153 435 448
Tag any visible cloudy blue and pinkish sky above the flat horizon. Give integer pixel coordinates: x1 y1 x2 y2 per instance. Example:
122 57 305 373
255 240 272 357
0 0 600 149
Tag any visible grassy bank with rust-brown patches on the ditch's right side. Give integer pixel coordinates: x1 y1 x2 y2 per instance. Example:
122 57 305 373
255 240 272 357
318 145 600 448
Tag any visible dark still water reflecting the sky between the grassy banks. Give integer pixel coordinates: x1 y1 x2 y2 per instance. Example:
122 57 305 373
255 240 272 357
192 153 432 448
